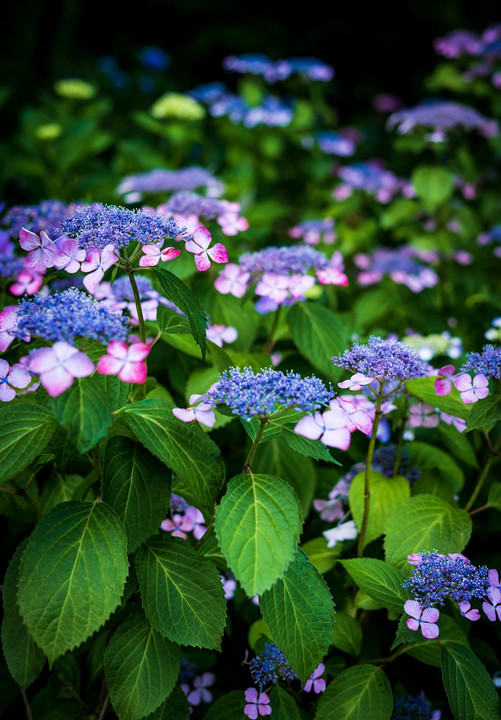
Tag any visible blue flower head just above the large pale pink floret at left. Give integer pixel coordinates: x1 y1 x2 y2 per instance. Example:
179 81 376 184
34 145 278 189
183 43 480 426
16 288 129 345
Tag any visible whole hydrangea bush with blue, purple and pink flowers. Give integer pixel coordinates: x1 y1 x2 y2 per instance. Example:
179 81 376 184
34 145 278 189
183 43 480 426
0 19 501 720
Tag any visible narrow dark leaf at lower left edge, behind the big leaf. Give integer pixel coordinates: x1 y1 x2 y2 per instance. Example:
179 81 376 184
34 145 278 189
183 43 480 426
2 539 46 690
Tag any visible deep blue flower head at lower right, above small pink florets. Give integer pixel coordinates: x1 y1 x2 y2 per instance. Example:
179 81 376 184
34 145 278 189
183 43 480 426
402 552 490 607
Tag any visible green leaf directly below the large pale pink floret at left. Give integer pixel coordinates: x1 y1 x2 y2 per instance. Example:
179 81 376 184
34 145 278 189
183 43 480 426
49 373 115 453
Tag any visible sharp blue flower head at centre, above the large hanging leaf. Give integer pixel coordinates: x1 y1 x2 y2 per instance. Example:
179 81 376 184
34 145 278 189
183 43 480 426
204 367 334 420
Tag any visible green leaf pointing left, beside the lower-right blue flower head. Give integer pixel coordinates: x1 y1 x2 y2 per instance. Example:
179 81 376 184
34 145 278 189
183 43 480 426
339 558 409 614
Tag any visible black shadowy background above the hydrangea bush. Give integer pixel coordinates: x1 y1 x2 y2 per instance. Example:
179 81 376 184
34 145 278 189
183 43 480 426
0 0 501 111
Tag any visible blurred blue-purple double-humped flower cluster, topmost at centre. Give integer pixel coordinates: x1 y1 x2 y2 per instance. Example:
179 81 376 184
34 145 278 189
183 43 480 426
223 53 334 83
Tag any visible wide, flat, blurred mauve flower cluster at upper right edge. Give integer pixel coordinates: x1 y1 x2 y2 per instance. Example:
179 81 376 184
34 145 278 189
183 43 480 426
387 100 499 138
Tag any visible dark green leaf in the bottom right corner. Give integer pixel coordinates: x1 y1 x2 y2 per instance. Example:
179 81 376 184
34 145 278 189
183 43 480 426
442 643 500 720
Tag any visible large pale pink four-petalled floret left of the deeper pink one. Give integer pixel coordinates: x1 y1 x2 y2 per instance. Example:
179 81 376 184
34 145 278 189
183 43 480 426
29 340 94 397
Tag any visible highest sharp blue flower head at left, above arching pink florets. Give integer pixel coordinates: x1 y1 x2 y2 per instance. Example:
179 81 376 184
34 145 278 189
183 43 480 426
57 205 184 250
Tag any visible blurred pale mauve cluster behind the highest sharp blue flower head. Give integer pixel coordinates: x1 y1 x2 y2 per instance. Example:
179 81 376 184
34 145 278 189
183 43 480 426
116 167 224 202
